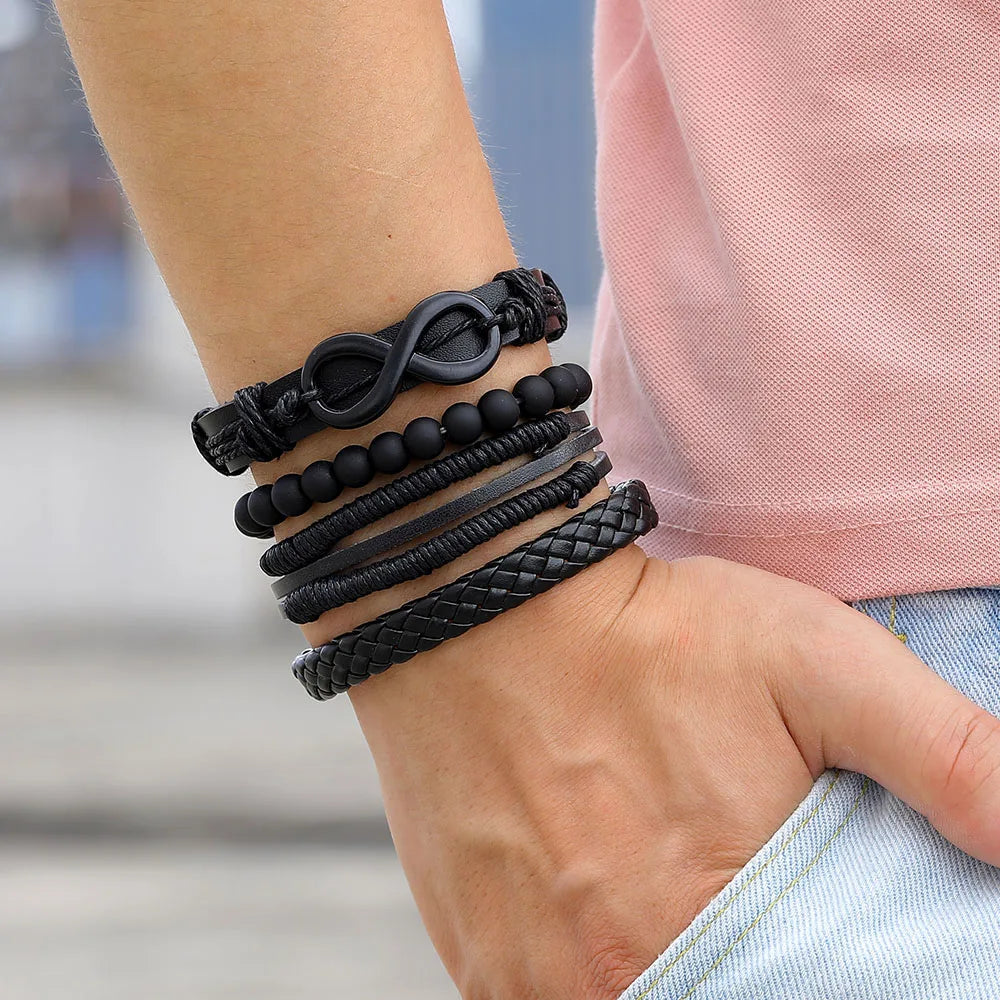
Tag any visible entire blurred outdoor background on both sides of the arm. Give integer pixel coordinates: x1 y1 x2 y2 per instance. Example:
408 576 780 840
0 0 599 1000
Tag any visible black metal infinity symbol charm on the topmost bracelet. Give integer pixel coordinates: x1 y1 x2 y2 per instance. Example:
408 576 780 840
302 292 501 429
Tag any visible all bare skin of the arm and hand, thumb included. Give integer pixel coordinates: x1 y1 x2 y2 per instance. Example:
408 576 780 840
58 0 1000 1000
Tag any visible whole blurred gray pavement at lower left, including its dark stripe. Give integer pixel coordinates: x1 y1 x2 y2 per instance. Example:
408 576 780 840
0 631 457 1000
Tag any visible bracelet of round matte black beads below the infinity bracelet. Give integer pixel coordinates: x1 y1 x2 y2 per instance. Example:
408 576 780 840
233 363 594 538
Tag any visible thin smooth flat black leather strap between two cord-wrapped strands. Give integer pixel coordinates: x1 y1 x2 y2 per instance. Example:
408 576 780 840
271 427 604 601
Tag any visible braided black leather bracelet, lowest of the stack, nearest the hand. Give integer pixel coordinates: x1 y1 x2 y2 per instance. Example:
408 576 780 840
292 480 657 701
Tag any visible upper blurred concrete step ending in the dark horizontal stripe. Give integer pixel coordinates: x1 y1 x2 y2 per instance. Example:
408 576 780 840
0 640 388 846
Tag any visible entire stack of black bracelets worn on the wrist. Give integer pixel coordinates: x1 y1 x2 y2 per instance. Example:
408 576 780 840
192 268 656 700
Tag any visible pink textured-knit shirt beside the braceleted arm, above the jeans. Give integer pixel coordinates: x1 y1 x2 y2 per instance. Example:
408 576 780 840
593 0 1000 600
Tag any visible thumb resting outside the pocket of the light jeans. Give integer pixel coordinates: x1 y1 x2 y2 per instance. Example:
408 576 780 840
785 605 1000 865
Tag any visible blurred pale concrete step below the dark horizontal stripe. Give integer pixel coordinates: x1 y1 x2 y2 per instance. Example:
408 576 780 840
0 841 457 1000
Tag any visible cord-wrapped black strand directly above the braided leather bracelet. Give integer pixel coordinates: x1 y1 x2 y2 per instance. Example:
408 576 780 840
274 452 611 625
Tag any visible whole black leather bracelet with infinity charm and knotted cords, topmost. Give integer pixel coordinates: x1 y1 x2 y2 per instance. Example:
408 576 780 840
191 268 566 475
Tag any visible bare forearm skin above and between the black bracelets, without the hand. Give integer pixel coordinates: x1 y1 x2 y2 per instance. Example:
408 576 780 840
52 0 640 680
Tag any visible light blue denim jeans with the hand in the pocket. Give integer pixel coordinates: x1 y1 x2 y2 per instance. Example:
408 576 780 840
622 587 1000 1000
